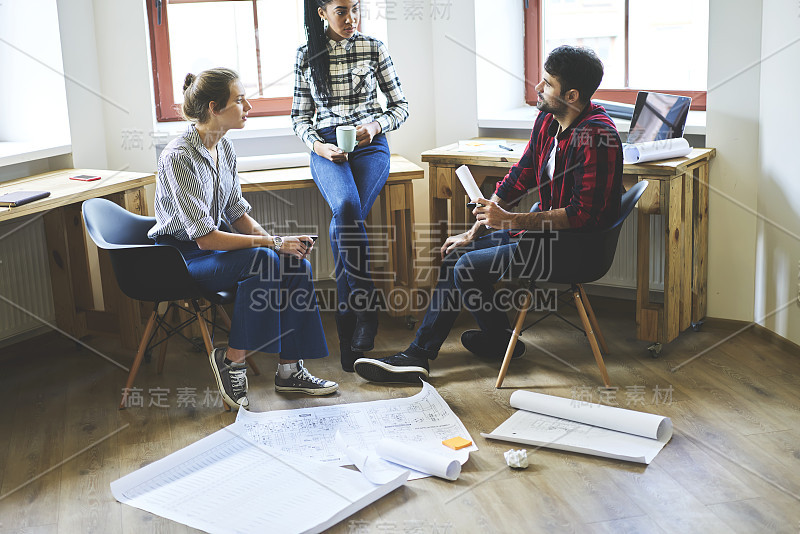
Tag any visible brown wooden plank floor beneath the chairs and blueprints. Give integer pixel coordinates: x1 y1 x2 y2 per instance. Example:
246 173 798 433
0 298 800 534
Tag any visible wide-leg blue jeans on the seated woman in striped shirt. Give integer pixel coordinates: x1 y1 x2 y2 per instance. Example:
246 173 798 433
159 238 328 360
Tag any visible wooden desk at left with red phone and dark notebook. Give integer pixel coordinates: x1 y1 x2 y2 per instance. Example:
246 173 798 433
0 169 155 348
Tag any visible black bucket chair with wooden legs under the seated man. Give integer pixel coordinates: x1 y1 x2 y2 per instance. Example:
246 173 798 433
495 180 647 388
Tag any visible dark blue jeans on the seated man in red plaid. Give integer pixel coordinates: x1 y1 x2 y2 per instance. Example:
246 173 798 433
408 231 550 360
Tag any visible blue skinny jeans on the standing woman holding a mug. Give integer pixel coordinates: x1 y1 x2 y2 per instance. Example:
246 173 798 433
311 127 389 311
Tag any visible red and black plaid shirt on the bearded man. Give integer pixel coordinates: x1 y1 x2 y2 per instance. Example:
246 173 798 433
495 104 622 230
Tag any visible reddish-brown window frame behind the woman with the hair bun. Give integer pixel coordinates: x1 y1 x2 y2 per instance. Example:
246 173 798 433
146 0 292 122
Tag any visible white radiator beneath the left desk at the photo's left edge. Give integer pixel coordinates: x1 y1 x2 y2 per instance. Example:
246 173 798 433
0 214 56 340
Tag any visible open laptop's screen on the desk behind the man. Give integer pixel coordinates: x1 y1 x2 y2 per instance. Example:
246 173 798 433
628 91 692 143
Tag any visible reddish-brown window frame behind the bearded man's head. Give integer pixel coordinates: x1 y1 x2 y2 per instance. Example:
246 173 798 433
523 0 706 111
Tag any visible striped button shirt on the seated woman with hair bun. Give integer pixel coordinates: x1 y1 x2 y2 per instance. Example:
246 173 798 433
147 124 251 241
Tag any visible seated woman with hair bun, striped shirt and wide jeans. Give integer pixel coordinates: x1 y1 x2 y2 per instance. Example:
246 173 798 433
148 68 339 409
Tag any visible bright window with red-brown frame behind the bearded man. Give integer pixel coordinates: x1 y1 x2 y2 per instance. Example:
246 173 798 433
525 0 708 110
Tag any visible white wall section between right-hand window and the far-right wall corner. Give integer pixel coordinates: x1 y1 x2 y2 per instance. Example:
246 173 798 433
706 0 761 321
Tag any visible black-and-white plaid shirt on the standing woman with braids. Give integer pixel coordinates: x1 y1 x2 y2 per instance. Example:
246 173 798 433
292 32 408 150
